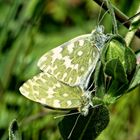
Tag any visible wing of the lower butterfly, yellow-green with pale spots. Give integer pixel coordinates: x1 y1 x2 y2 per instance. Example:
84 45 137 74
20 72 83 109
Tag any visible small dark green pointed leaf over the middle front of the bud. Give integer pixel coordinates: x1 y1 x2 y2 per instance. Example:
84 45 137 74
104 59 128 83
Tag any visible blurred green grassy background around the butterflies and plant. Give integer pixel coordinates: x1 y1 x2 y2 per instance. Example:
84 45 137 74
0 0 140 140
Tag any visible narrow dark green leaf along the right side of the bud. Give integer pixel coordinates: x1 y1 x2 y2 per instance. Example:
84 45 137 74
124 47 136 74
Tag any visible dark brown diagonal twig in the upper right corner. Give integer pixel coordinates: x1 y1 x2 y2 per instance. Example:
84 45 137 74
93 0 140 38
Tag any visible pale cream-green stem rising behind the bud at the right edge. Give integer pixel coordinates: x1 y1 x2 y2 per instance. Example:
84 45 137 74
125 4 140 46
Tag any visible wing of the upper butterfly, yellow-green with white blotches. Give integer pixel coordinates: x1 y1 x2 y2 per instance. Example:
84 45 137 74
38 34 99 86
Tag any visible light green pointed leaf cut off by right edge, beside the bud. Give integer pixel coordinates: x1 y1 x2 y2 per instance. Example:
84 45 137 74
128 65 140 92
